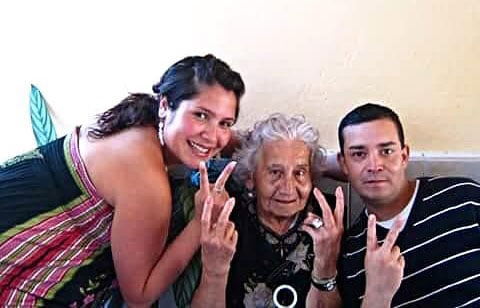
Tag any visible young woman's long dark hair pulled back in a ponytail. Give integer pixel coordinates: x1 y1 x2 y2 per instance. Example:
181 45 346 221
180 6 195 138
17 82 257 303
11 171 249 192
88 54 245 139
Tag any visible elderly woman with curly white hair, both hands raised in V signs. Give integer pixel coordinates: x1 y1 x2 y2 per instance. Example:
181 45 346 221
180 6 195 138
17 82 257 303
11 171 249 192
192 113 344 307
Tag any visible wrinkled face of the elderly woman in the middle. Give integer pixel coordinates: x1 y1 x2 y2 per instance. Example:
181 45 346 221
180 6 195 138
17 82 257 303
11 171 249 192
249 140 312 220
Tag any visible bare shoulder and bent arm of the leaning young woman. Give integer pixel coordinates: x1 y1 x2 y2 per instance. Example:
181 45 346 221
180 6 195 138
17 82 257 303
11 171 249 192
82 128 200 307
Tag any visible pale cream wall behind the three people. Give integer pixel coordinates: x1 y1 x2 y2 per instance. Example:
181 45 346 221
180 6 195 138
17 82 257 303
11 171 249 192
0 0 480 160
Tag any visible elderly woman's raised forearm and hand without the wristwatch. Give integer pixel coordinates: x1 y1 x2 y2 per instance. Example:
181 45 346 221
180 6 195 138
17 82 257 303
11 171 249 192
192 198 238 308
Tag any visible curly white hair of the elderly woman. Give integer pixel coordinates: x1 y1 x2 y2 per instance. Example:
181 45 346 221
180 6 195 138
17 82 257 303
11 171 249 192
233 113 326 182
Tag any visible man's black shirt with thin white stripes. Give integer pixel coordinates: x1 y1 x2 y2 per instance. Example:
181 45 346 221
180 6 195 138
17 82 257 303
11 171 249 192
339 177 480 307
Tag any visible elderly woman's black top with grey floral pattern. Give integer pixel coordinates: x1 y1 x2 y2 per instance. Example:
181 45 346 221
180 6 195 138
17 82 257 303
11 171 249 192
226 182 335 307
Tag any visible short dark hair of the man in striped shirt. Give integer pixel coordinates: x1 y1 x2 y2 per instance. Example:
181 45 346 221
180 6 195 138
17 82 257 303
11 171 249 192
338 103 405 155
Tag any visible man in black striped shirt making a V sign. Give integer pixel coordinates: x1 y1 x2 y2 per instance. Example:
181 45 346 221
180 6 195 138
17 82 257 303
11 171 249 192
338 104 480 307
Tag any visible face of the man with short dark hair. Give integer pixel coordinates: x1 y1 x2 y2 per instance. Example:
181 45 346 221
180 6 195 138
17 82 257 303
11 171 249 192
339 119 409 205
